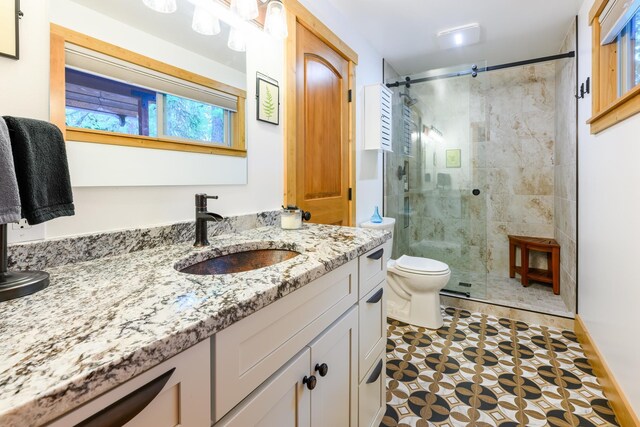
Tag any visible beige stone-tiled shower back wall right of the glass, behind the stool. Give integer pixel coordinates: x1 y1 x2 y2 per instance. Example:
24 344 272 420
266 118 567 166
472 63 556 277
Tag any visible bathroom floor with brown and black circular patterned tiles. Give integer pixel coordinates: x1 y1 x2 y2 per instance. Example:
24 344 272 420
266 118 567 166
380 308 618 427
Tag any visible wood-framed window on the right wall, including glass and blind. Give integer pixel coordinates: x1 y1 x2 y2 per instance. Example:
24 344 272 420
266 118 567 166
588 0 640 134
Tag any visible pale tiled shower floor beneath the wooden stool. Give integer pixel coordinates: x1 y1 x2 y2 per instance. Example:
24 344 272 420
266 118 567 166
445 272 574 317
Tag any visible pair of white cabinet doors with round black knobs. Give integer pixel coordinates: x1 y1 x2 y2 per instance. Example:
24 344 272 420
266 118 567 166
216 307 358 427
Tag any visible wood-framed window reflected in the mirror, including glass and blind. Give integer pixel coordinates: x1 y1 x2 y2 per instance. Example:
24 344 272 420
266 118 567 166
50 24 246 157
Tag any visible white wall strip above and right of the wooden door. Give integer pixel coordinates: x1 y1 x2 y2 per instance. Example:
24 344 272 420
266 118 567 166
300 0 382 224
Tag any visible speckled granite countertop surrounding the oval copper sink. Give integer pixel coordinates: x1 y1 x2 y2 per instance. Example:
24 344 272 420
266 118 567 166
0 225 391 427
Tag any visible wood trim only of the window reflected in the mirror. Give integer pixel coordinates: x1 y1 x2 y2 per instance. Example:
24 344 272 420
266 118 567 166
49 24 247 157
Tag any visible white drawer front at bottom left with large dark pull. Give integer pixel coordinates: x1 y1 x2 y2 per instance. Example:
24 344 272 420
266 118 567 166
48 341 211 427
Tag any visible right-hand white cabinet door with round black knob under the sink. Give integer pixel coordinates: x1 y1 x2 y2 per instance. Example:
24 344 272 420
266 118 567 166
309 307 358 427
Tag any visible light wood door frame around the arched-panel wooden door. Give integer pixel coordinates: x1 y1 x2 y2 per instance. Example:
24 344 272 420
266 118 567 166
284 0 358 226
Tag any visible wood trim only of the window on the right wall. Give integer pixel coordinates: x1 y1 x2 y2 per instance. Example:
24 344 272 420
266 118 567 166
587 0 640 134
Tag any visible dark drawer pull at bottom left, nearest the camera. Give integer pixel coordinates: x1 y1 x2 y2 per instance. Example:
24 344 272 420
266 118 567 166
76 368 176 427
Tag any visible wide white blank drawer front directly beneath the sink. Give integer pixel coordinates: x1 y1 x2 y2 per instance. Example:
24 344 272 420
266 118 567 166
212 260 358 421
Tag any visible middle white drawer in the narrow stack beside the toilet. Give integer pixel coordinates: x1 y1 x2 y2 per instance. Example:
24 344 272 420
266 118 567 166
358 280 387 380
